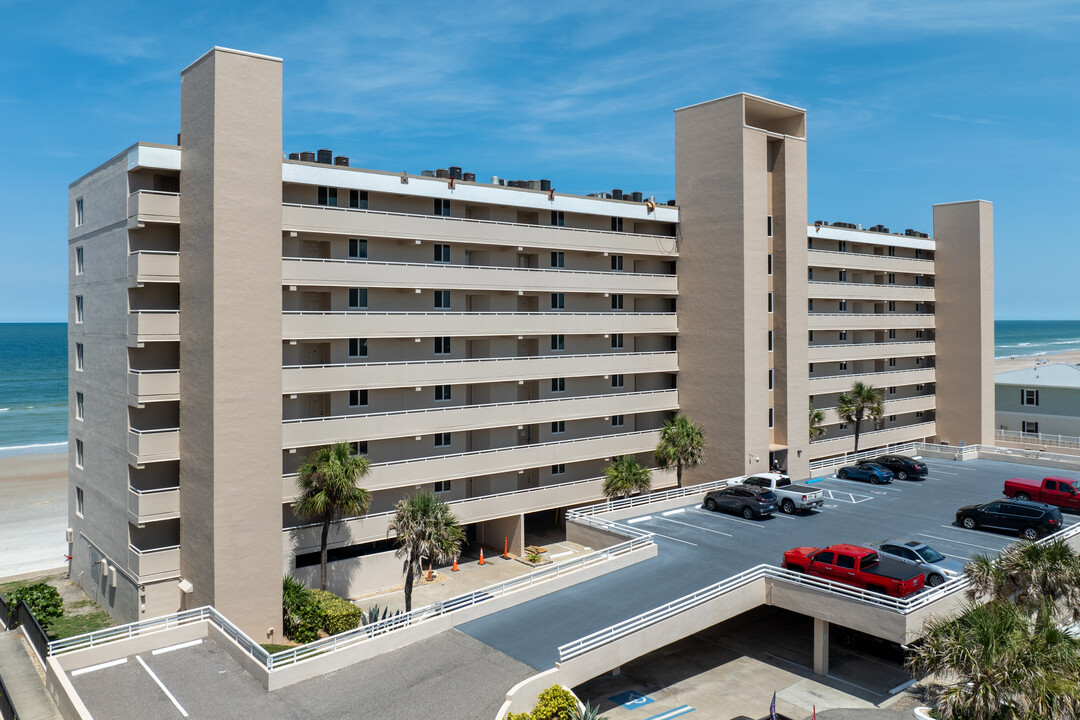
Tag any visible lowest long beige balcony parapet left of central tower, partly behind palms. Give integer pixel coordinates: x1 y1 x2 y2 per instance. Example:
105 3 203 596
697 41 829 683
283 470 675 546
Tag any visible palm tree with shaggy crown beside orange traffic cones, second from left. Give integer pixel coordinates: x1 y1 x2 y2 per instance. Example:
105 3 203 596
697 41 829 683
387 492 465 612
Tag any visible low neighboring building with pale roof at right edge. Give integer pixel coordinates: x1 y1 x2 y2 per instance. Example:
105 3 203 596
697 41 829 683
995 363 1080 437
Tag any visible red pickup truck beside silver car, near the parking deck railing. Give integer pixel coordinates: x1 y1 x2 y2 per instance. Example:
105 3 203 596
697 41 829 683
783 545 926 598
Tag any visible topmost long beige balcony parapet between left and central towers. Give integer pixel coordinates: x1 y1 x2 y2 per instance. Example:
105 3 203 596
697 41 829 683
281 203 678 259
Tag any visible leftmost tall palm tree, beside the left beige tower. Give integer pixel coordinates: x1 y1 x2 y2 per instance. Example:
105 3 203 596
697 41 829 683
293 443 372 590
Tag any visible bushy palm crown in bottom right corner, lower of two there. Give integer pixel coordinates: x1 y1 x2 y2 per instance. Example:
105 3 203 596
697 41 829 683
908 600 1080 720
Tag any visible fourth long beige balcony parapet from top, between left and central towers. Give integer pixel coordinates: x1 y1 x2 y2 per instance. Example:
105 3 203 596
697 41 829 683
282 343 678 394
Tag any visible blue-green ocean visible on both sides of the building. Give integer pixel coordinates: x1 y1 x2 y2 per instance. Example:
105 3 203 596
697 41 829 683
0 320 1080 457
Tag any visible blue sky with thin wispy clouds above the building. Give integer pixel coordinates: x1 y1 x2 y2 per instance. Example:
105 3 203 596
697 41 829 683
0 0 1080 322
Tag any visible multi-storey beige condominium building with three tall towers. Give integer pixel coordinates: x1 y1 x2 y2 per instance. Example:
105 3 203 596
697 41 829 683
69 49 994 638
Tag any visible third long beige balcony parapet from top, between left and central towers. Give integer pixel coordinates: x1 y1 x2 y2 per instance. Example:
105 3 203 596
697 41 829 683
282 310 678 340
